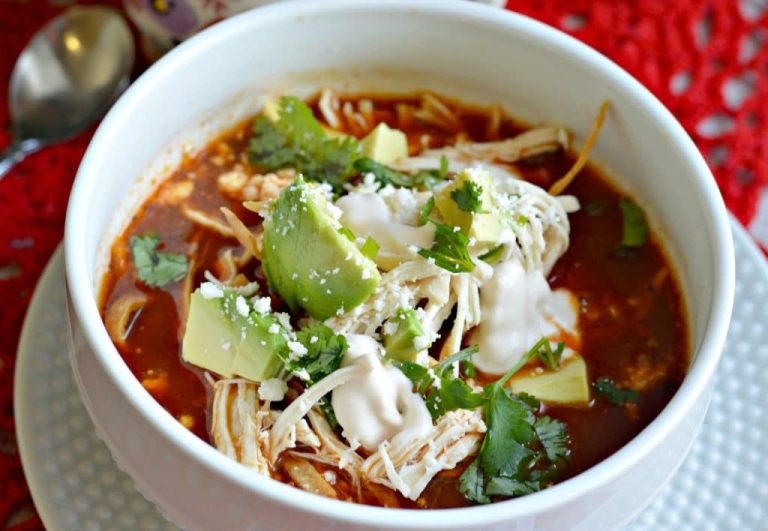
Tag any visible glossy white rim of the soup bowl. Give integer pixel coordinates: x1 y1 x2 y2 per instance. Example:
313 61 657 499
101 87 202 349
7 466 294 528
65 0 735 528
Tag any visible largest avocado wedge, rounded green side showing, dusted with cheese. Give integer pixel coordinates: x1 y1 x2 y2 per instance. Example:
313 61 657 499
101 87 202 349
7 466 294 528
262 176 381 320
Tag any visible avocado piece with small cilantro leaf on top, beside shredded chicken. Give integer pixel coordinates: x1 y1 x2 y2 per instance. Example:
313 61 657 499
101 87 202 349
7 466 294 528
435 168 501 244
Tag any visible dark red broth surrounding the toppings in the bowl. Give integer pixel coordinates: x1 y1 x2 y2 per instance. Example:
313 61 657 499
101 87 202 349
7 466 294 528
100 95 689 508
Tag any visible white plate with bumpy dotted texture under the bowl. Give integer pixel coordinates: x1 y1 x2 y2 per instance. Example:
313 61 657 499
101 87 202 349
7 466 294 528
14 218 768 531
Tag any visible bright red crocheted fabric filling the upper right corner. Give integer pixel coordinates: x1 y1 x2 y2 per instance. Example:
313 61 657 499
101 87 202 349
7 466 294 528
507 0 768 252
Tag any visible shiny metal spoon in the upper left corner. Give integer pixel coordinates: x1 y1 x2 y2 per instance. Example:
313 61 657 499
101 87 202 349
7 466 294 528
0 6 134 179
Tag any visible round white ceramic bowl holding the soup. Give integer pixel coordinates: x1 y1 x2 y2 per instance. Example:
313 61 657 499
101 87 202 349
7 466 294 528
66 0 734 529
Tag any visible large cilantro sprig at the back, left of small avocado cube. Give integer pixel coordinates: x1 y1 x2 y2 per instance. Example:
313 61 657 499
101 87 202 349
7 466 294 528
248 96 360 190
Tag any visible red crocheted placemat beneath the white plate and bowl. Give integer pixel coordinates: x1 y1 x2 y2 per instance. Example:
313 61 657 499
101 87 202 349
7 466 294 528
0 0 768 529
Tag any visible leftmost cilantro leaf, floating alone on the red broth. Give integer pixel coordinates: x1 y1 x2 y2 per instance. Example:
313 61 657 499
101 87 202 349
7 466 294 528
131 232 189 287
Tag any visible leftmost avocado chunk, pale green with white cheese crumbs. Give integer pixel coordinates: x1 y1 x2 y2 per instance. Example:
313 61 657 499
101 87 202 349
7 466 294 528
181 289 286 382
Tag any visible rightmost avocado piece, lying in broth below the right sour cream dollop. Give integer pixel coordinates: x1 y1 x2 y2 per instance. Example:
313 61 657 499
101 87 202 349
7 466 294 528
509 357 590 404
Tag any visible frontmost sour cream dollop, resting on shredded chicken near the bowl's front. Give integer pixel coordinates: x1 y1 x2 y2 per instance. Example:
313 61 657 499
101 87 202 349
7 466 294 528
331 334 432 452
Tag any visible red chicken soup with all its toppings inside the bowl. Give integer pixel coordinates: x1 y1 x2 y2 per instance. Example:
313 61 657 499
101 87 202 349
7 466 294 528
100 90 689 509
